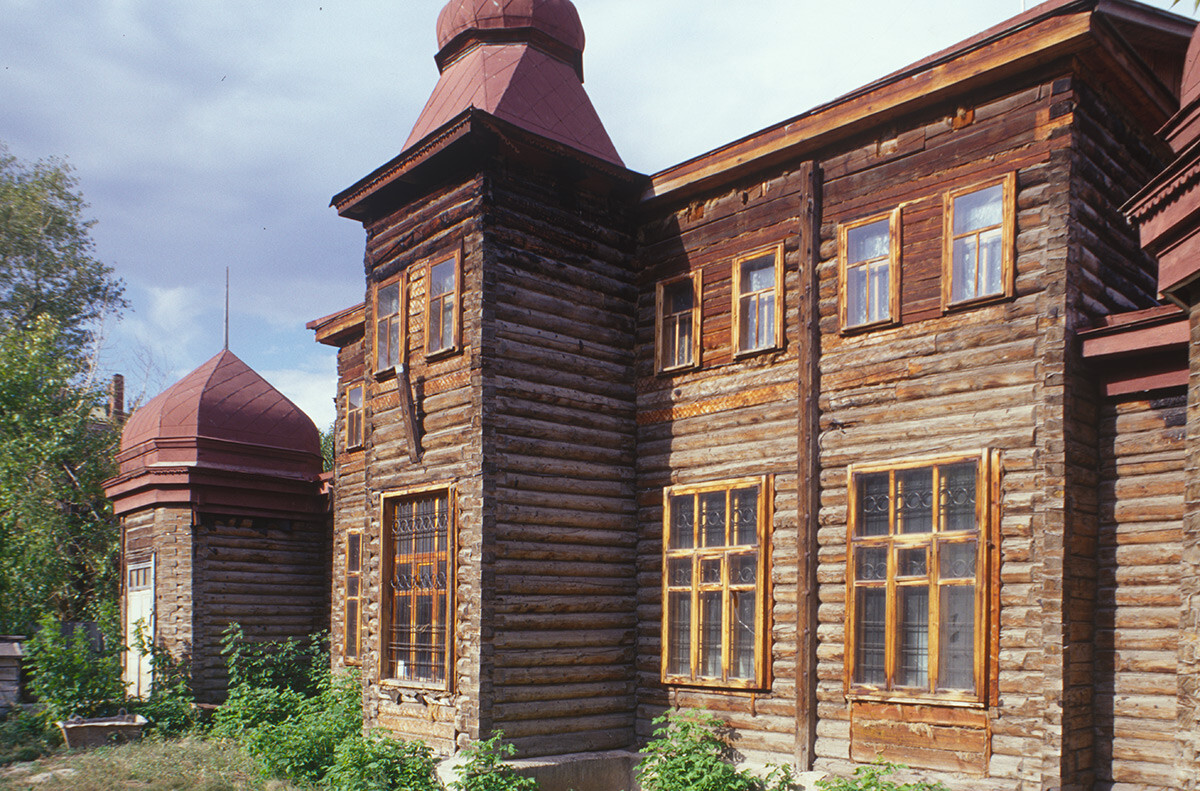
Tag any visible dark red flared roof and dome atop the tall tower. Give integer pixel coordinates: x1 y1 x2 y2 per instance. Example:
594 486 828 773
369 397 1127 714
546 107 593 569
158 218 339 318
404 0 623 164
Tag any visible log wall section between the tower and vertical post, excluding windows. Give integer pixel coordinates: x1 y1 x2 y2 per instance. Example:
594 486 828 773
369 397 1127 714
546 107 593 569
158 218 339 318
637 166 811 760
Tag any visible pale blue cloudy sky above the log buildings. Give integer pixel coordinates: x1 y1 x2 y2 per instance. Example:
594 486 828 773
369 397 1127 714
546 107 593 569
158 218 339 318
0 0 1193 426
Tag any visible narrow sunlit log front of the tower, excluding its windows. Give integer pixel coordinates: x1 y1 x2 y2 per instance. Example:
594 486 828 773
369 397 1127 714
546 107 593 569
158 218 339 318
355 179 490 753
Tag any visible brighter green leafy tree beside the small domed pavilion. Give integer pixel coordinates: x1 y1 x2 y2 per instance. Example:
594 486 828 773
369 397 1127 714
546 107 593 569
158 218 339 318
0 306 116 630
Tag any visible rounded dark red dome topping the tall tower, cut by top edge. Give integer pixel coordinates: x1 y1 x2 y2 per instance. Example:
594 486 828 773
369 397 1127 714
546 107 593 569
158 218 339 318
438 0 583 52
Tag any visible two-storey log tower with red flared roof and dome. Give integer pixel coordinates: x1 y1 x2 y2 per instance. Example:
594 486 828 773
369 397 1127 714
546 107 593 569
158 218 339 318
326 0 646 772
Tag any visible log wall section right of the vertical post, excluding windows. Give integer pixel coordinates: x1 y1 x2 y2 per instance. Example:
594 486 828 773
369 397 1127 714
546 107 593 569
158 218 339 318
816 72 1069 789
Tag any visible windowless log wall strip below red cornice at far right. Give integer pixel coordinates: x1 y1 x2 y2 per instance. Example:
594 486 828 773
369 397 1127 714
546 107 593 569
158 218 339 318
1094 391 1187 791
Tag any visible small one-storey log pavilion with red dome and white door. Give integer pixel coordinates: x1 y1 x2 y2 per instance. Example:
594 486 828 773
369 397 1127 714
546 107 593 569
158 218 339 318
104 349 330 703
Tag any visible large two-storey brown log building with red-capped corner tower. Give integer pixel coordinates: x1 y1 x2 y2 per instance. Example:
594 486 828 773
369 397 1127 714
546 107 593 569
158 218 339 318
310 0 1200 791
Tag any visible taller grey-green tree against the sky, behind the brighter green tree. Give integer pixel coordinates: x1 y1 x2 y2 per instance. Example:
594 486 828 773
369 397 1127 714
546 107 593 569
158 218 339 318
0 143 127 355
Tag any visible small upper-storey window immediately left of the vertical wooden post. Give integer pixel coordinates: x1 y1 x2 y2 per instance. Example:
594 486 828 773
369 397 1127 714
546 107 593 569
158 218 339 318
733 245 784 354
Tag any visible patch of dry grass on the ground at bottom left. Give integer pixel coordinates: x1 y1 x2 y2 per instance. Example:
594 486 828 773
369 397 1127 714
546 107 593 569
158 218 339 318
0 737 306 791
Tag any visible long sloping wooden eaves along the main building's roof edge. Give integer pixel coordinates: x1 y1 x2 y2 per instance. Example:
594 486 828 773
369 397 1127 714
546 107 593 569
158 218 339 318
643 0 1194 207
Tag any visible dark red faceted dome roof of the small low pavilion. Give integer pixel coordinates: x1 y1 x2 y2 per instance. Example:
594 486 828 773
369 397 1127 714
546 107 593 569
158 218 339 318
121 350 320 455
